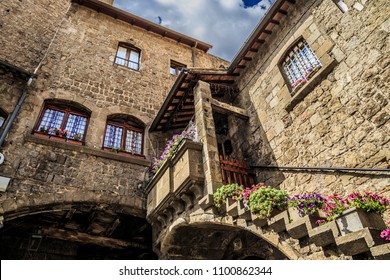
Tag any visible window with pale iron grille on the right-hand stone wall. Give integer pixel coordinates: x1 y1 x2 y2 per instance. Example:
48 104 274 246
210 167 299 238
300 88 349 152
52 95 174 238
281 39 322 95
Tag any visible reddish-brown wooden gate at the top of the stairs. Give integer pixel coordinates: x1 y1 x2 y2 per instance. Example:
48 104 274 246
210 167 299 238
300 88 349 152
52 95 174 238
219 156 255 187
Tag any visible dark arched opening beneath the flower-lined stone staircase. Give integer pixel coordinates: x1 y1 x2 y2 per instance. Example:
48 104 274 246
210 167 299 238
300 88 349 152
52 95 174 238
159 218 297 260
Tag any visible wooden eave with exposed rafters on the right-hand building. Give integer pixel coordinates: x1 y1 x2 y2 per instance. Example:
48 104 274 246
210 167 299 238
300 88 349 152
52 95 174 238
228 0 296 74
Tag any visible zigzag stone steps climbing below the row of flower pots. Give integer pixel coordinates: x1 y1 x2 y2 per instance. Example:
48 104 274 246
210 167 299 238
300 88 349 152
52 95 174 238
199 195 390 260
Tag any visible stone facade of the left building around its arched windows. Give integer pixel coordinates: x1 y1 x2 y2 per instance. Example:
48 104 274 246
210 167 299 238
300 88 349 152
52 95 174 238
0 1 227 219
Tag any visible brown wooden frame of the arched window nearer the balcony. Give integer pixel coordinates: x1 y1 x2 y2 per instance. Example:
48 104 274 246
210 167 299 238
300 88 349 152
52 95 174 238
103 118 145 158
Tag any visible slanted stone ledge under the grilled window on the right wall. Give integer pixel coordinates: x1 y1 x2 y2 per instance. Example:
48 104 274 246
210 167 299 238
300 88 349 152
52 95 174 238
285 59 337 112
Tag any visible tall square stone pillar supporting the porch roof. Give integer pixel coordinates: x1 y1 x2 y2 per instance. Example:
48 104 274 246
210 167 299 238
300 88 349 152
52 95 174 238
194 81 222 195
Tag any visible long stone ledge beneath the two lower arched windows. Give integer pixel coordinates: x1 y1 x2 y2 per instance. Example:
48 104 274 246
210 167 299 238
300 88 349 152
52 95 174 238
25 134 150 167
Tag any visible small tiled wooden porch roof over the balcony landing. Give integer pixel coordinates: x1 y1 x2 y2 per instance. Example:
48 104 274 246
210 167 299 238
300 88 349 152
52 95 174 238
150 69 238 132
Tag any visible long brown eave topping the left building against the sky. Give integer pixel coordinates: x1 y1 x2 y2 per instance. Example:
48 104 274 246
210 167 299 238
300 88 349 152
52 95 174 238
72 0 213 52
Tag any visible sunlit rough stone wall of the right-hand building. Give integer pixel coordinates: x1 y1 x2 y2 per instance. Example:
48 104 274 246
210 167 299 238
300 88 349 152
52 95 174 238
235 0 390 206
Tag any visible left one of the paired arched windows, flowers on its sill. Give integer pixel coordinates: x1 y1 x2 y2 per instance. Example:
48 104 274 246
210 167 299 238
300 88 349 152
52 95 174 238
34 101 90 142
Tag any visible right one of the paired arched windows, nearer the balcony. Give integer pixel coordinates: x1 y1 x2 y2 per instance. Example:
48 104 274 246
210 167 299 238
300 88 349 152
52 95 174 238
104 116 144 155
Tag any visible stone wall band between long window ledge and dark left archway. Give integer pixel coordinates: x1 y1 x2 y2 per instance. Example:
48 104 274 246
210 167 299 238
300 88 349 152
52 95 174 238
0 135 148 217
